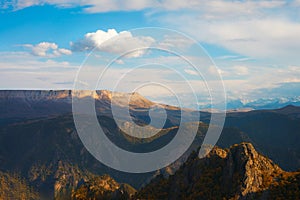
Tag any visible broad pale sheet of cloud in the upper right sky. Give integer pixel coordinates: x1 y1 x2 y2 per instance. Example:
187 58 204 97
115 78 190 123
159 13 300 61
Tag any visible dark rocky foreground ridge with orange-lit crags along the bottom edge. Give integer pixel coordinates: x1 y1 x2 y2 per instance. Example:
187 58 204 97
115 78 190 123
0 143 300 200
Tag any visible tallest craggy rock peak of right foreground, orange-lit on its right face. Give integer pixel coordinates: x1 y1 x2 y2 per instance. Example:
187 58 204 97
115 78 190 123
223 143 283 196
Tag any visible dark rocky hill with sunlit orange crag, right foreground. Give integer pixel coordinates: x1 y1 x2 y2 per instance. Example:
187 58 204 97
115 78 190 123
136 143 299 199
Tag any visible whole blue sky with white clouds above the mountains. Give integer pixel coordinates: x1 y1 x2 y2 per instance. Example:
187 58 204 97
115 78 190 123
0 0 300 108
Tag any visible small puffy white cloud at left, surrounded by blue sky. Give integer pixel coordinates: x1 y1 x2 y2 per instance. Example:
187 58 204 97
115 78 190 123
22 42 72 58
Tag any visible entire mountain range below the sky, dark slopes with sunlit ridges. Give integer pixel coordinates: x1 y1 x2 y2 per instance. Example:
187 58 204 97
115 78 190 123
0 90 300 199
